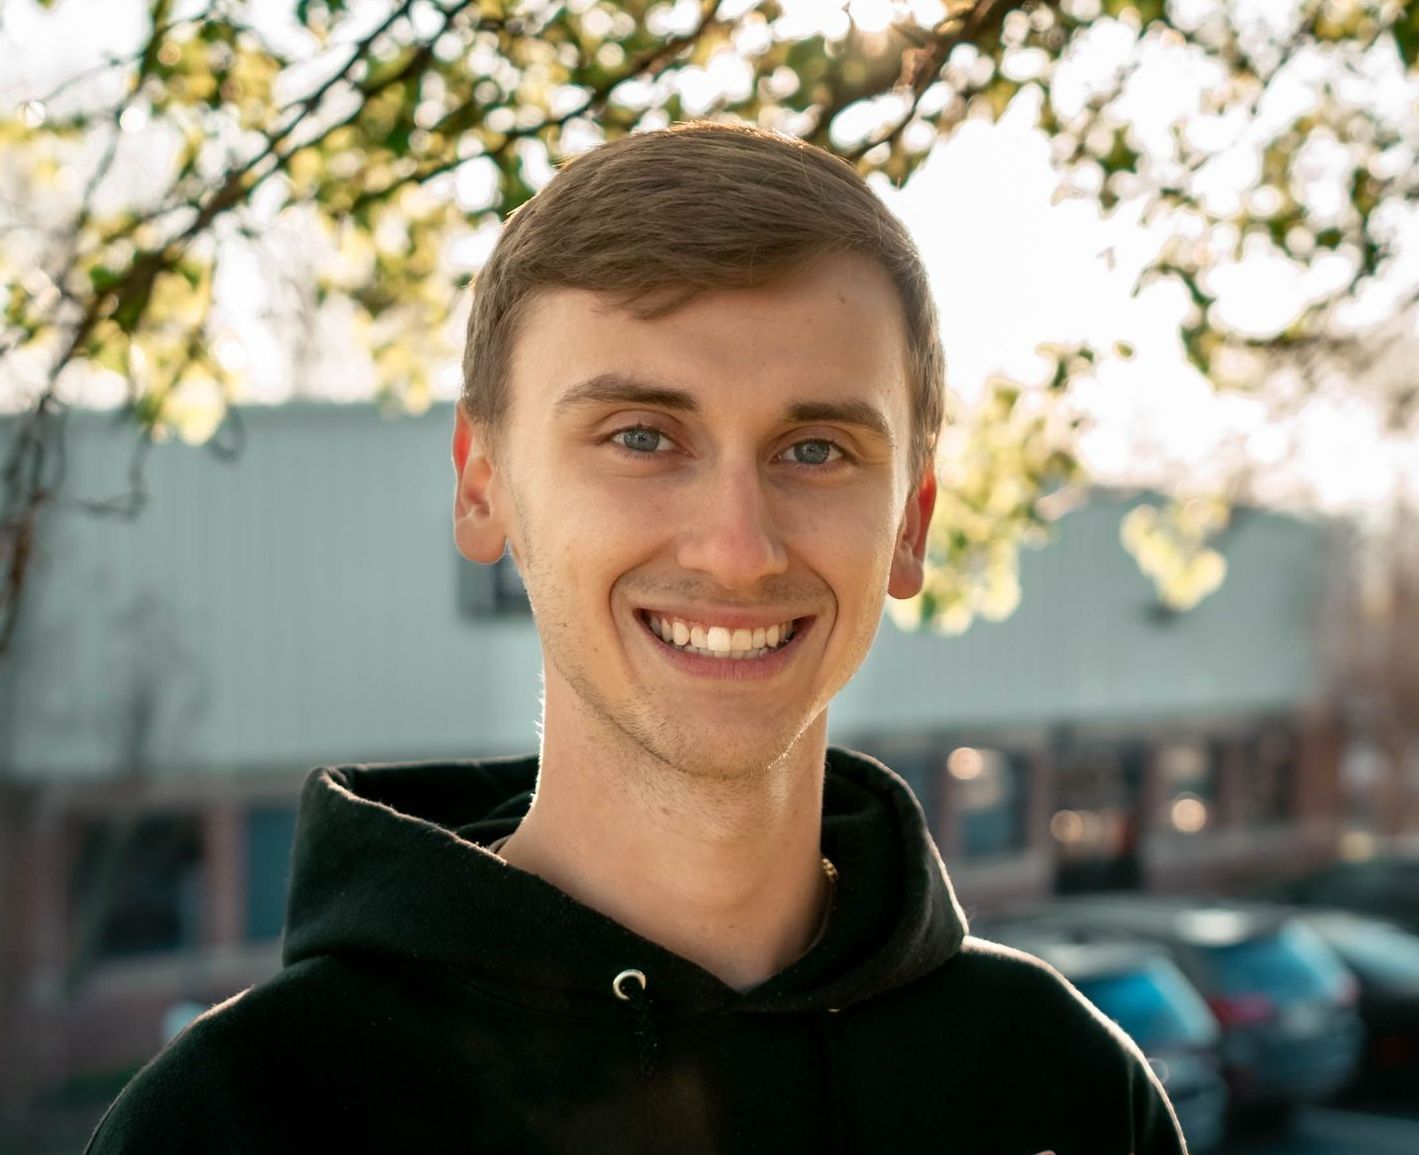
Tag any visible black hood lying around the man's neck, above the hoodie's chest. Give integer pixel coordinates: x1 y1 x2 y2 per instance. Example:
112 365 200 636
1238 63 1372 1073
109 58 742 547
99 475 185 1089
284 749 966 1015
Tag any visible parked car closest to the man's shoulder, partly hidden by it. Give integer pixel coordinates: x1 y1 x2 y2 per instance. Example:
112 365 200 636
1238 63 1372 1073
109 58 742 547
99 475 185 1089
985 927 1227 1152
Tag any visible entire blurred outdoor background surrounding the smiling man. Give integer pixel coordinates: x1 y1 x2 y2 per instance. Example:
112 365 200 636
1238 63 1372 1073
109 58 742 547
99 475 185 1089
0 0 1419 1155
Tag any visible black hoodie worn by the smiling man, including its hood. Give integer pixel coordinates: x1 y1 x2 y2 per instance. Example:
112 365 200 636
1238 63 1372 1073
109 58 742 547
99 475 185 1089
80 751 1183 1155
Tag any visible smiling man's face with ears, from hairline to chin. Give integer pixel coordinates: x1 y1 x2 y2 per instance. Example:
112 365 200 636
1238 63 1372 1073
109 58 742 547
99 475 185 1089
454 257 935 778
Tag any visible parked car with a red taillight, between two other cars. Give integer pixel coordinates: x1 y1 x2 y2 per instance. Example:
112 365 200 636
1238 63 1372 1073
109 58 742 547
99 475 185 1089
987 895 1364 1117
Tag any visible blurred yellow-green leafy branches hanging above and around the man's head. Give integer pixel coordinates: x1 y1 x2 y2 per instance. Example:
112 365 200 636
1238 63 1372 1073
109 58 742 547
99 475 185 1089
0 0 1419 650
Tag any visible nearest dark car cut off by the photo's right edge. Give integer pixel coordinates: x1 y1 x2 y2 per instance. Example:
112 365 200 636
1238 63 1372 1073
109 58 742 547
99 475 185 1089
1304 911 1419 1103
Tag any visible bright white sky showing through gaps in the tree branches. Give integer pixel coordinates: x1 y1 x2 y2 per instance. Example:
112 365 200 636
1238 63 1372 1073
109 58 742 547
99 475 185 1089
0 0 1419 508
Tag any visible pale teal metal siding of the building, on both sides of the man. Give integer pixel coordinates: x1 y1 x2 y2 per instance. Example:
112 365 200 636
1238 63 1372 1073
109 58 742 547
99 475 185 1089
0 404 1323 778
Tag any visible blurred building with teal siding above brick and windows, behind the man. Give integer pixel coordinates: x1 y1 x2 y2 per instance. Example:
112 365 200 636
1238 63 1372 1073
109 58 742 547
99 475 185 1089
0 406 1337 1129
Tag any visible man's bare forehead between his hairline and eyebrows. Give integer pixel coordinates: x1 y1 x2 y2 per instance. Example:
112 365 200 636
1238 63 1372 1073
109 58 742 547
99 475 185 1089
508 254 910 436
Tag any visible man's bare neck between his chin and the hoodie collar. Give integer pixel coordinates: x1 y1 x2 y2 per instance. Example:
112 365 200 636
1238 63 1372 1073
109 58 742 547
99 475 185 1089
501 700 830 990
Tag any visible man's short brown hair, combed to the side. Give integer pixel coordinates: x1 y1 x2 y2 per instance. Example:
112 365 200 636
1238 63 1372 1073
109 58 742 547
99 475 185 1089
463 121 945 477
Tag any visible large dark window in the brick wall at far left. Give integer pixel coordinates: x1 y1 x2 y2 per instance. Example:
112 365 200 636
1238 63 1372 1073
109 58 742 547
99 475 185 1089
70 814 201 969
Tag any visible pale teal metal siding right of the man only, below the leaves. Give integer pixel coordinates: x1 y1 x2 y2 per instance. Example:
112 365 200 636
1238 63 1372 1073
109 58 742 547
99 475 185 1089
834 501 1325 729
